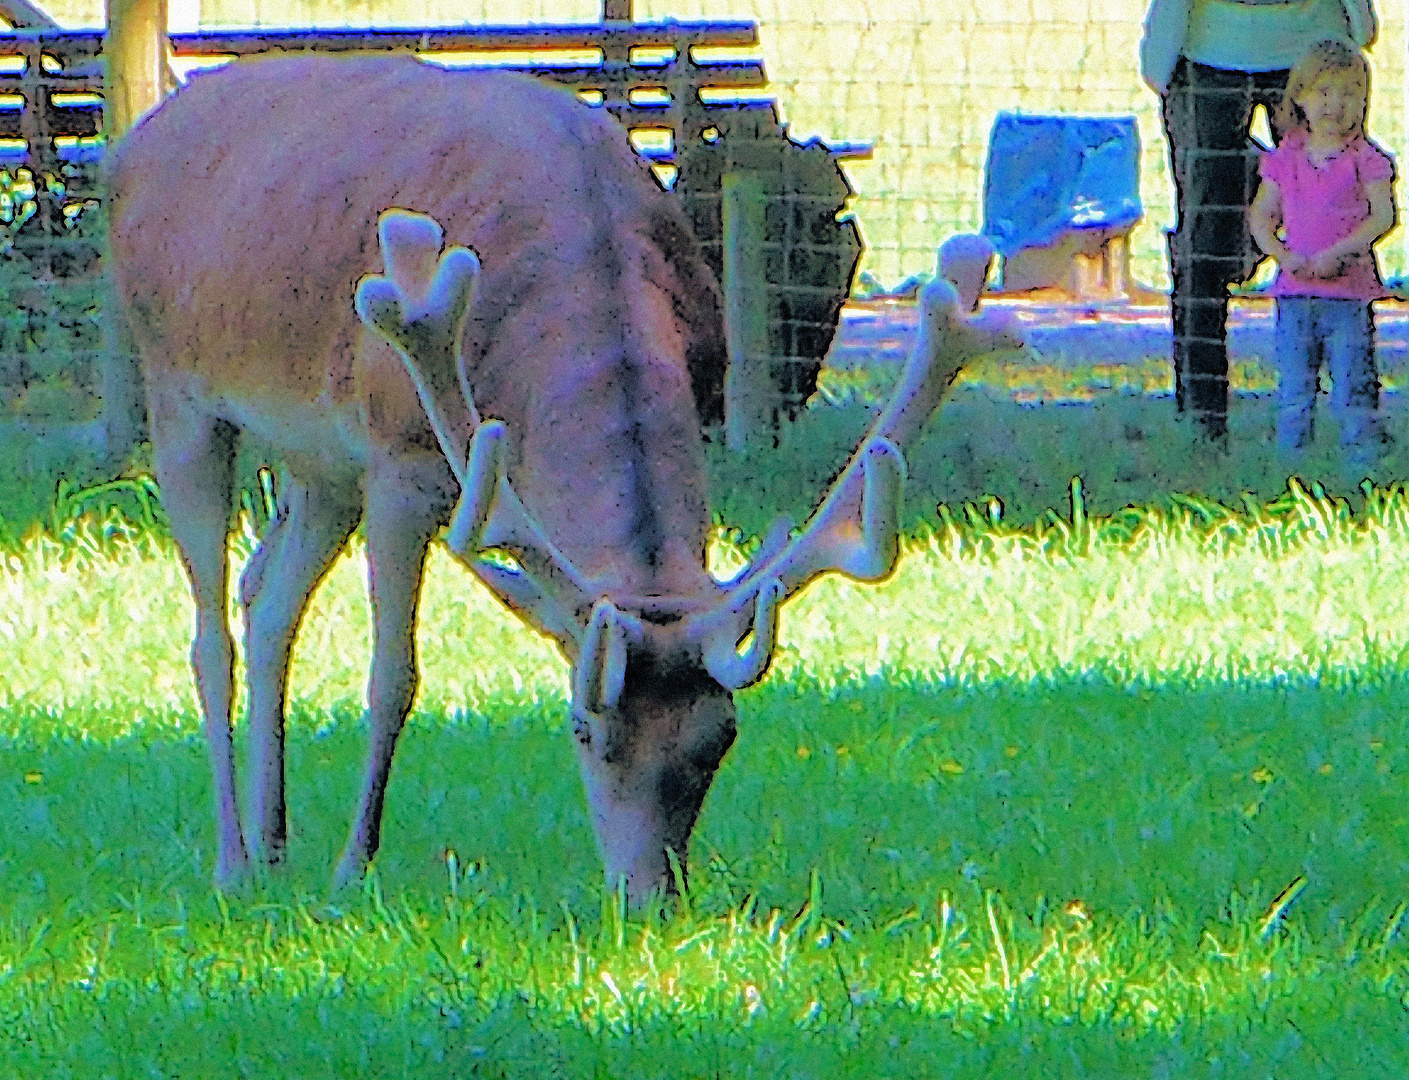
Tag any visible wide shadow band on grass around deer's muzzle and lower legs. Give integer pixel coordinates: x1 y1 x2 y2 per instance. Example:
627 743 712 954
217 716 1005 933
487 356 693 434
0 677 1409 935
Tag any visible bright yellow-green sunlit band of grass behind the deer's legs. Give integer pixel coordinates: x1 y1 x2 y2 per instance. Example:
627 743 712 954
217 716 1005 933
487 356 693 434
13 480 1409 718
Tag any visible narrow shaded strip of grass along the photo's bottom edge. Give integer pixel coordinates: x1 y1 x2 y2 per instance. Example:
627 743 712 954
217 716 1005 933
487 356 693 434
7 987 1409 1080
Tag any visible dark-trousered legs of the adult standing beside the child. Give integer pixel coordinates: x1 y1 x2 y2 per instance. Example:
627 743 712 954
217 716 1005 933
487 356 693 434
1162 59 1286 439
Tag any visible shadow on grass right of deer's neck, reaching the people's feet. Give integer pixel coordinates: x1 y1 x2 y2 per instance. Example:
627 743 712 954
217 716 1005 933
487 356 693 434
710 386 1409 535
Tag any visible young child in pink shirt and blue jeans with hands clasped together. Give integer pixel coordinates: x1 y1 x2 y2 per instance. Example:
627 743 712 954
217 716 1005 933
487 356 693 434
1250 41 1395 476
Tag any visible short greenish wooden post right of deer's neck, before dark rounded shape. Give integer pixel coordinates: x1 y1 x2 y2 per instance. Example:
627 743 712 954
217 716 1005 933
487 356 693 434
721 169 779 452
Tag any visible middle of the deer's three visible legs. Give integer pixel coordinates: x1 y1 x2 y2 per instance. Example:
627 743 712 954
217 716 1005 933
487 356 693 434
240 470 362 866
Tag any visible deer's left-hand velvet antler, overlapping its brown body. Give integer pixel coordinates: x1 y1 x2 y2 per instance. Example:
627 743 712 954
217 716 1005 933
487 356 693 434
355 210 592 659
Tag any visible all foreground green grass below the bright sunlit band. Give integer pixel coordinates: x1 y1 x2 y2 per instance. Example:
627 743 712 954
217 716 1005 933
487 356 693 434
0 687 1409 1077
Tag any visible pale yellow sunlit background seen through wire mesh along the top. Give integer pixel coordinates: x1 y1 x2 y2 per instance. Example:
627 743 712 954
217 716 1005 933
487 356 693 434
16 0 1409 287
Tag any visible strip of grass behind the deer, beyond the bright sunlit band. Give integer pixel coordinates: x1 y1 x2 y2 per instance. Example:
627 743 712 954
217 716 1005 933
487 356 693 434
0 358 1409 551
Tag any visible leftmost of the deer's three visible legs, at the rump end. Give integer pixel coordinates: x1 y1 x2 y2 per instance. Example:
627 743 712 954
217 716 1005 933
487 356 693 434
151 394 248 886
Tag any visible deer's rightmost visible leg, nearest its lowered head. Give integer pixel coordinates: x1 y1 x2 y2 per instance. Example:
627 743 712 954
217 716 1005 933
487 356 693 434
334 455 454 889
